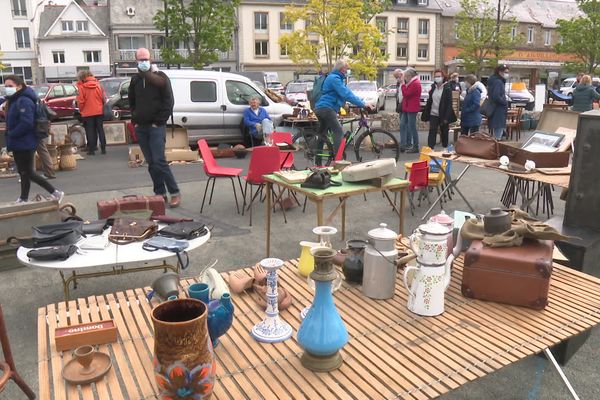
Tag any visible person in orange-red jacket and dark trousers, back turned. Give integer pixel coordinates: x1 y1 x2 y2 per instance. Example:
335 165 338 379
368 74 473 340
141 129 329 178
77 70 106 156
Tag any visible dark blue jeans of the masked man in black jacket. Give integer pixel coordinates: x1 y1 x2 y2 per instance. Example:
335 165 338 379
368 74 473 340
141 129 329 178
135 125 179 196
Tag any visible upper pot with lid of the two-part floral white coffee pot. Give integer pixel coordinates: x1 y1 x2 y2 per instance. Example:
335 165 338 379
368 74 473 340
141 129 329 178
409 222 452 265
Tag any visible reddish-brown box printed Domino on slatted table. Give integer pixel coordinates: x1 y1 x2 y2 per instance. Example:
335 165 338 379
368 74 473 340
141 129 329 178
54 319 118 351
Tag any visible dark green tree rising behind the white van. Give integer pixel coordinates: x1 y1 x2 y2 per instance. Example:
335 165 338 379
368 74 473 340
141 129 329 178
154 0 239 69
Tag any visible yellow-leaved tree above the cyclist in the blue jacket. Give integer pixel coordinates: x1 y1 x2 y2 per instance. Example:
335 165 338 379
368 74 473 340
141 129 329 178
279 0 390 78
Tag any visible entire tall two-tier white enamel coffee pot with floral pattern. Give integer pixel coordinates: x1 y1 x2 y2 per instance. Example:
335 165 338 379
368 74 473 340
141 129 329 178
404 222 454 316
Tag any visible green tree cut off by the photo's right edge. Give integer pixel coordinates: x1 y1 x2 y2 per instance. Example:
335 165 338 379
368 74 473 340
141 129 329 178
554 0 600 74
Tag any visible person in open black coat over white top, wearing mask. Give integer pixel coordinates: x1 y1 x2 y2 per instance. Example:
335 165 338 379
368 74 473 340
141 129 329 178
421 69 456 149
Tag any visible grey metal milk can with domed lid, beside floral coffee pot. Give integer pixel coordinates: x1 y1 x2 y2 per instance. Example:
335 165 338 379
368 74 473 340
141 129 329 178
362 224 398 299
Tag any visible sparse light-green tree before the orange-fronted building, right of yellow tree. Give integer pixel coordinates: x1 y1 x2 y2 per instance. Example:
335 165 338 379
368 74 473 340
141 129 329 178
456 0 523 75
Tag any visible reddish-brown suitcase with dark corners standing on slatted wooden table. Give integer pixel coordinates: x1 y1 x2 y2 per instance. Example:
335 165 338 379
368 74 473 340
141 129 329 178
461 239 554 310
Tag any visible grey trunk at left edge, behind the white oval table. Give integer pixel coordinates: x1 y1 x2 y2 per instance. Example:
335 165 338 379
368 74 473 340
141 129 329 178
0 200 61 246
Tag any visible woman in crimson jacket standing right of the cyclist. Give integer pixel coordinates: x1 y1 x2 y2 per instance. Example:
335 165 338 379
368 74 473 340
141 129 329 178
400 68 421 153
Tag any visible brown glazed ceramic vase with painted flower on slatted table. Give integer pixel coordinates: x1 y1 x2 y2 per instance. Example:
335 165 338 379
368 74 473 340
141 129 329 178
152 299 216 400
